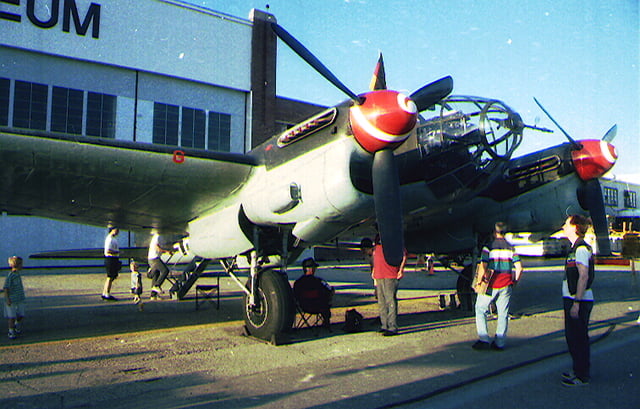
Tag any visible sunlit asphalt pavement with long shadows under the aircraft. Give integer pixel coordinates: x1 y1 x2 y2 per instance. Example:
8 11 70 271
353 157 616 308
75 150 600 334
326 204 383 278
0 260 640 409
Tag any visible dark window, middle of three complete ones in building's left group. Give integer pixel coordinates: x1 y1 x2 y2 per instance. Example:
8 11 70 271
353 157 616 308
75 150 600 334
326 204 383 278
51 87 84 135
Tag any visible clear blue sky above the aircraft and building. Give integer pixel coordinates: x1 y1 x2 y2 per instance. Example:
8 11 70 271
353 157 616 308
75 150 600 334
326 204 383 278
189 0 640 183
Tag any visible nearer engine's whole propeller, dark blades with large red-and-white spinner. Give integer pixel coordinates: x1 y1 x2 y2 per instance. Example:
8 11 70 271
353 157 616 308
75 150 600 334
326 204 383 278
271 23 453 266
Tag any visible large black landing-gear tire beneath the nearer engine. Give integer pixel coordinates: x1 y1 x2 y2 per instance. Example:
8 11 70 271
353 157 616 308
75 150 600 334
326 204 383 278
244 269 295 340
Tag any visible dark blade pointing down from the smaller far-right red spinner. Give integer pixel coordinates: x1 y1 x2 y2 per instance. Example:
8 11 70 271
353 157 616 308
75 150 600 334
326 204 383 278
577 179 611 256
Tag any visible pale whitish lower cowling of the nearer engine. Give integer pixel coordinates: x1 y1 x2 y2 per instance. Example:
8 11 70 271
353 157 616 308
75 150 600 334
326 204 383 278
242 139 373 243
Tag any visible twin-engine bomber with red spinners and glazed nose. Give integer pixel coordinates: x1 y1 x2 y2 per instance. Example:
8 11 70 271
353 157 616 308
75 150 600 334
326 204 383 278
0 23 617 340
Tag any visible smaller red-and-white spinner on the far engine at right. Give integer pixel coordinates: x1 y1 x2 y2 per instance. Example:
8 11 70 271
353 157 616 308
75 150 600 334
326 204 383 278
571 139 618 181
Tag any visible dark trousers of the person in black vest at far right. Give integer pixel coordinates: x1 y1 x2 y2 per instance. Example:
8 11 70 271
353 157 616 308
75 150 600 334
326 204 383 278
563 298 593 381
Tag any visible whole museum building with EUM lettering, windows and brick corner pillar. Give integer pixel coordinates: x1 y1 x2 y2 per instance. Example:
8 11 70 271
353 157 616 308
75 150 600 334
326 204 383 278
0 0 322 267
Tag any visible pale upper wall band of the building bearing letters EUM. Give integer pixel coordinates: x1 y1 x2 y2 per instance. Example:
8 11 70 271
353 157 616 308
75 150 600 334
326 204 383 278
0 0 251 91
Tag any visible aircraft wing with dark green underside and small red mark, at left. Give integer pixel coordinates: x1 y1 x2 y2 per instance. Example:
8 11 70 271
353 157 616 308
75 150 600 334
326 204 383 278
0 130 256 233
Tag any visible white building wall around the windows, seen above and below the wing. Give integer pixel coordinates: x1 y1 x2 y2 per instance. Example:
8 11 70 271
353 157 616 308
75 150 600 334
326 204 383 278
0 0 252 267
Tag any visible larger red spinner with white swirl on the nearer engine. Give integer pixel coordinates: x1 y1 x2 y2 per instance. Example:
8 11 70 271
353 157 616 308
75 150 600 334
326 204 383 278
349 90 418 153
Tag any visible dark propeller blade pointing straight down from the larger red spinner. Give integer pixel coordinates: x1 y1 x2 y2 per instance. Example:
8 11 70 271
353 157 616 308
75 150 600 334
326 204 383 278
371 149 404 267
